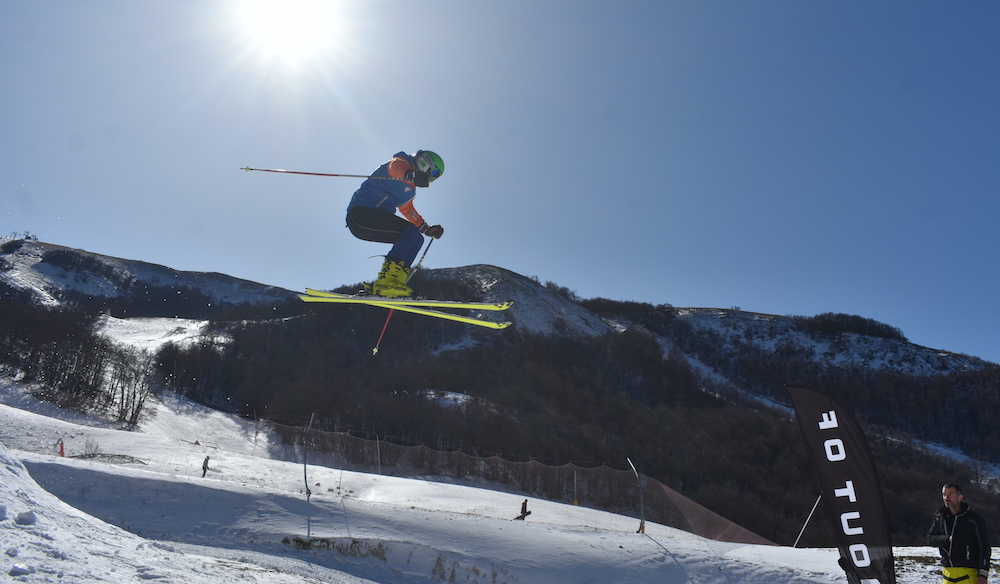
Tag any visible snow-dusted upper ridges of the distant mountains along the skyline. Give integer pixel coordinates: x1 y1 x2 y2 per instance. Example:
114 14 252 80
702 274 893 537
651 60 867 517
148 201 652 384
0 238 987 376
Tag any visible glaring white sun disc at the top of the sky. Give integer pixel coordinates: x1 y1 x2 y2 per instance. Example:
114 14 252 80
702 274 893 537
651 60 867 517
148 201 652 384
235 0 345 63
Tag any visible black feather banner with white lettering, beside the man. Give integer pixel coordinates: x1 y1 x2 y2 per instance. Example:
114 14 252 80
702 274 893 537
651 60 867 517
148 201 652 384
788 387 896 584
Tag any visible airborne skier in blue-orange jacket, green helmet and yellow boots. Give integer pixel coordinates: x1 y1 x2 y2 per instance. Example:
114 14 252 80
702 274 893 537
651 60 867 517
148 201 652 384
347 150 444 298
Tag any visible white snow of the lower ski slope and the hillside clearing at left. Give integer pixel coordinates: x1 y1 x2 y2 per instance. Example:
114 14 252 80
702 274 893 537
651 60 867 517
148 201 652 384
0 312 960 584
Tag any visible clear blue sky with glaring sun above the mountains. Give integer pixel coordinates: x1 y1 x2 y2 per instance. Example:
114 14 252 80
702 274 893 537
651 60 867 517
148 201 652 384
0 0 1000 362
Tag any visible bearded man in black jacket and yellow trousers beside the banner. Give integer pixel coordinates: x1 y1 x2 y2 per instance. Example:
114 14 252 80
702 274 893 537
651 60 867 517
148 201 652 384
927 483 990 584
